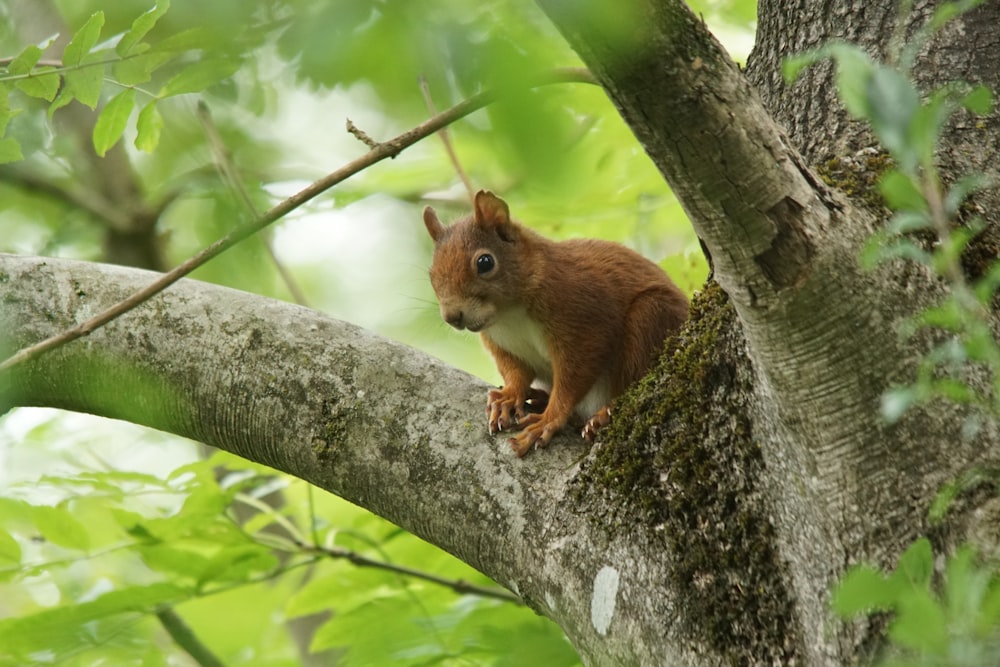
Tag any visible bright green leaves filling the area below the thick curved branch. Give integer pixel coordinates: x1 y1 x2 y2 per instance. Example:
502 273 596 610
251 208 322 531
0 424 576 666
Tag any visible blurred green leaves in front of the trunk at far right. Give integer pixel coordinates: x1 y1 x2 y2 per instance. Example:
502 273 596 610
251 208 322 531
785 0 1000 665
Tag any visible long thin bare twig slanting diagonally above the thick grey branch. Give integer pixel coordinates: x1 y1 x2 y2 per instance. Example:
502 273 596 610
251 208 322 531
0 68 594 371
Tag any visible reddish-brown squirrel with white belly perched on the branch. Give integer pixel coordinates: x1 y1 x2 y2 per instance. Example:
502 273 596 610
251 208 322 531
424 190 688 458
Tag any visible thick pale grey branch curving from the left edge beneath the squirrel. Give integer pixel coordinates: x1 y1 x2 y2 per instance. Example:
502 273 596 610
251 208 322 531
0 255 714 664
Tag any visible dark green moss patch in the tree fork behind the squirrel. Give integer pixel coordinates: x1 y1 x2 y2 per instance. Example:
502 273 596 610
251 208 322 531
578 283 799 664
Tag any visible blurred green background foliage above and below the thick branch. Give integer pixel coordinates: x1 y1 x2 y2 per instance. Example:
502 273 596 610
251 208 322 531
0 0 756 665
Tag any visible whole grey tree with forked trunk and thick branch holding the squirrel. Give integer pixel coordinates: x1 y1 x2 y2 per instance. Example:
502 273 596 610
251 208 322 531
0 0 1000 665
